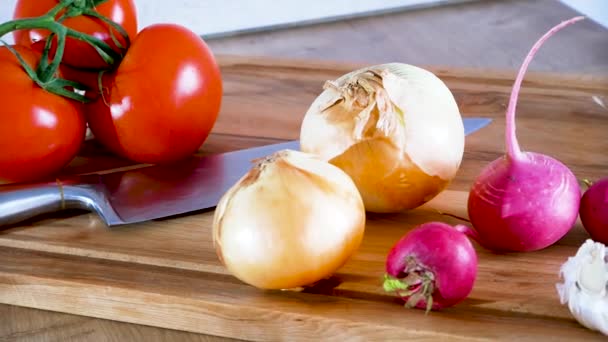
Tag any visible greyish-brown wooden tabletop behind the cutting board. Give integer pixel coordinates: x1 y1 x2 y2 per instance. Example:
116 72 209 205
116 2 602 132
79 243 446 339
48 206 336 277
209 0 608 75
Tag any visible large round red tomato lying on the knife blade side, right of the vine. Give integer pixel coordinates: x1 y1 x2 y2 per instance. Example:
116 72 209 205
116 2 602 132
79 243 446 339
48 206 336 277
86 24 222 164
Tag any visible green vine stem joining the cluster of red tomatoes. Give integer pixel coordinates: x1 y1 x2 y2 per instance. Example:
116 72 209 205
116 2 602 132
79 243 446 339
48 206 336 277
0 0 130 102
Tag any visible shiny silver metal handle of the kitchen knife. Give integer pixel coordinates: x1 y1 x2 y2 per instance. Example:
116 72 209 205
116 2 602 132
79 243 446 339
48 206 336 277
0 182 118 226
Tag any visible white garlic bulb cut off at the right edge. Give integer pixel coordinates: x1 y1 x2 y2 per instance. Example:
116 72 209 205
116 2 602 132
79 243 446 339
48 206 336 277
556 239 608 335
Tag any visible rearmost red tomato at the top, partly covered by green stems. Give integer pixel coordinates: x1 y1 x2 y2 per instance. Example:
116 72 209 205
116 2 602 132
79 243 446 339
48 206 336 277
13 0 137 69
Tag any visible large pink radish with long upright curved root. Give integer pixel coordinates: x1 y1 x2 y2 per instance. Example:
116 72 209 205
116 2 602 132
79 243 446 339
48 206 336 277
468 17 583 252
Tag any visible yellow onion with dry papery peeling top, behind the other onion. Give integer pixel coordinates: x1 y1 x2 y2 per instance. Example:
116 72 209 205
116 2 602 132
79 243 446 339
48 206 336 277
300 63 464 212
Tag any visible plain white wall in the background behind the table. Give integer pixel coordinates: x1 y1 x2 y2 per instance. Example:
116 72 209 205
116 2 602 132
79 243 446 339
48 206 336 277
0 0 608 43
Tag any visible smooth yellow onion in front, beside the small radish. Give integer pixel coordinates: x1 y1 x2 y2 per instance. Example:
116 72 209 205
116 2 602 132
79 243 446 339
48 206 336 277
213 150 365 289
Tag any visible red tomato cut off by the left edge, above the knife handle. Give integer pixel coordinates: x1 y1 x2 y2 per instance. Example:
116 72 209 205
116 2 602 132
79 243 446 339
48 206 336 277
0 46 86 183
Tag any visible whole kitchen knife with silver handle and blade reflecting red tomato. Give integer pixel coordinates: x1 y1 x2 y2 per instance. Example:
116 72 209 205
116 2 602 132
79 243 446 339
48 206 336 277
0 118 491 226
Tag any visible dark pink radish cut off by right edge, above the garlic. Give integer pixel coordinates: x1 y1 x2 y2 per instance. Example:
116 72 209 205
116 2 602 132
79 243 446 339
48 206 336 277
579 178 608 245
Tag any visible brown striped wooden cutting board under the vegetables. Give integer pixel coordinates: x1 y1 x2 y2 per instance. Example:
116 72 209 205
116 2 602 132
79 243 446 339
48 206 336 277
0 56 608 341
